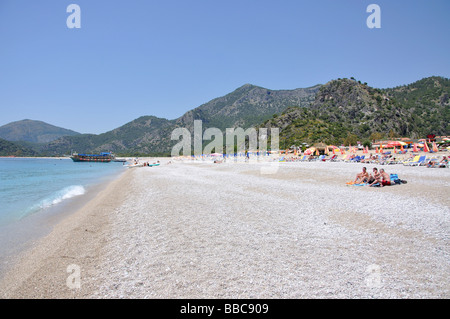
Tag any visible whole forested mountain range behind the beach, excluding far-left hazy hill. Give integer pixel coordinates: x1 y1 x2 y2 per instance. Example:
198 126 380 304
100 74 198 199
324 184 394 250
0 77 450 156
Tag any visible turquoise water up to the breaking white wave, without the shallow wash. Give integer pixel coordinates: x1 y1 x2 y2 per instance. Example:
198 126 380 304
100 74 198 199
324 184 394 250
0 158 124 226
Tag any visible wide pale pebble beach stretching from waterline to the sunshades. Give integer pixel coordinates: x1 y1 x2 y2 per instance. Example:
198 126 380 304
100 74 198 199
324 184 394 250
0 159 450 299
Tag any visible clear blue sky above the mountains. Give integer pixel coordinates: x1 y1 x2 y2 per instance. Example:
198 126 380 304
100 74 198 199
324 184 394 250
0 0 450 134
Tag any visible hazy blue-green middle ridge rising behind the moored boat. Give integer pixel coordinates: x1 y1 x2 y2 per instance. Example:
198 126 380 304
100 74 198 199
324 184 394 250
39 84 320 155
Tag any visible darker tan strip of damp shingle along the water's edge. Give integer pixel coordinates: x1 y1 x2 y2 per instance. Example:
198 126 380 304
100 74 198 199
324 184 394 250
0 171 134 299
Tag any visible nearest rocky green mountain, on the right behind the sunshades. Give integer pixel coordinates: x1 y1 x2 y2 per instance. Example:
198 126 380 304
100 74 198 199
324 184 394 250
261 77 450 148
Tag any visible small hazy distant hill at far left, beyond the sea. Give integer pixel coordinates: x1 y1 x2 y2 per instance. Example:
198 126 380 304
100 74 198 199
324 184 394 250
0 120 80 143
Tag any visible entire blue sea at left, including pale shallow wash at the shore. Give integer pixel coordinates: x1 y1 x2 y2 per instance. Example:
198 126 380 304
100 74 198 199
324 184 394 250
0 158 125 275
